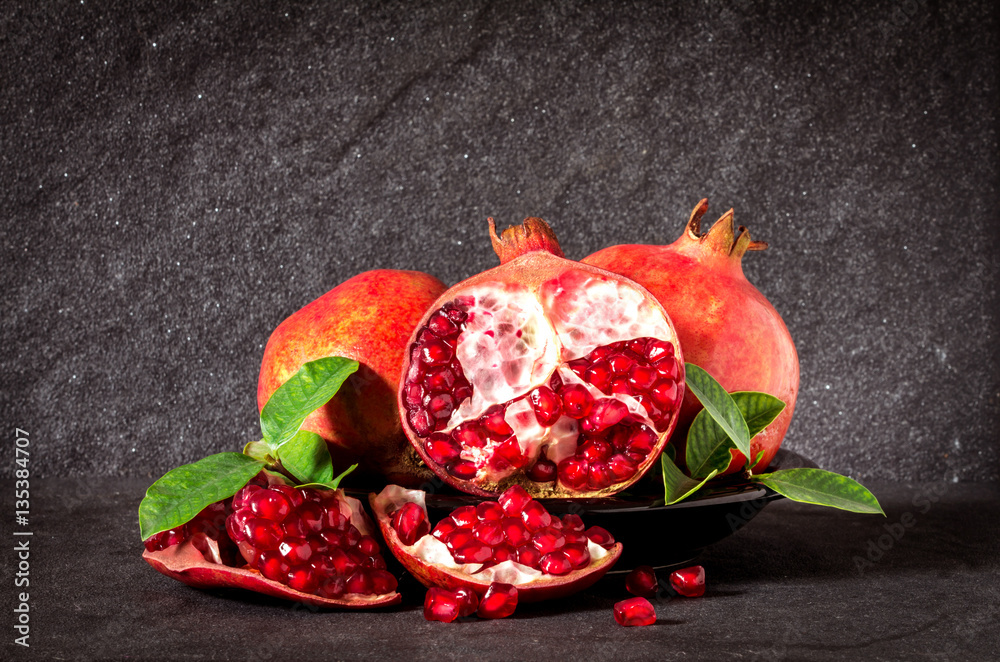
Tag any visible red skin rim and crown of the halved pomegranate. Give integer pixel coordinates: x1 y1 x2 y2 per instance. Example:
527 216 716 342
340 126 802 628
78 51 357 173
397 218 685 498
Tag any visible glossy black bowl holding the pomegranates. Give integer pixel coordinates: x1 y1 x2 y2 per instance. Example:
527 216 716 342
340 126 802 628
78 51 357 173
418 449 816 573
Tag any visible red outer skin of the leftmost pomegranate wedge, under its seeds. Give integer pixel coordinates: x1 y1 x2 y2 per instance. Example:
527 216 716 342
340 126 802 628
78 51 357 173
142 542 402 609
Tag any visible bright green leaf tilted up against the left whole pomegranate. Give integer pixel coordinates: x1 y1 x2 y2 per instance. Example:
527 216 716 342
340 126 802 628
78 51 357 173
260 356 358 449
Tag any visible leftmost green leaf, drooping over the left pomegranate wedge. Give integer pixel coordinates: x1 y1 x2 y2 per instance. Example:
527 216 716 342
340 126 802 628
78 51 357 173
139 453 264 540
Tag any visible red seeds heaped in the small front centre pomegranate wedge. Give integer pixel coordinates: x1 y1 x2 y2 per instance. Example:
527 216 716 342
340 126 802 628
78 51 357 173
420 485 614 576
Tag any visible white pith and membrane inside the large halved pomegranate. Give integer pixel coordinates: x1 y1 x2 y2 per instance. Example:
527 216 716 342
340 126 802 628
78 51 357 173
408 268 676 490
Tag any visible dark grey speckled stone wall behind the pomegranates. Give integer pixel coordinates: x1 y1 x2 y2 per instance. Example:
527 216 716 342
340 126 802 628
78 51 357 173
0 0 1000 481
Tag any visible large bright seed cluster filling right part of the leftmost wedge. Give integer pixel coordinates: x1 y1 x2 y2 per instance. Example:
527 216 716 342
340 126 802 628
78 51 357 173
226 484 396 598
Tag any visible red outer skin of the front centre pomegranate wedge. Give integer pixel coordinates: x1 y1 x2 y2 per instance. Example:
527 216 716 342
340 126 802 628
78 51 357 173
368 494 622 603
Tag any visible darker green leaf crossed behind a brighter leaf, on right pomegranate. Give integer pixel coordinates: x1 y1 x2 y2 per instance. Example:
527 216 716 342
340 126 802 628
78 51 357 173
684 391 785 478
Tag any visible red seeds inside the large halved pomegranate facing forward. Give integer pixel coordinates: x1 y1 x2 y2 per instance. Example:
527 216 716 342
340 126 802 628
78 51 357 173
403 294 680 491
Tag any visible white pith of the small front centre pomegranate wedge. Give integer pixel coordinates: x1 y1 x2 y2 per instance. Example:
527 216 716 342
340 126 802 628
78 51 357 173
372 485 611 586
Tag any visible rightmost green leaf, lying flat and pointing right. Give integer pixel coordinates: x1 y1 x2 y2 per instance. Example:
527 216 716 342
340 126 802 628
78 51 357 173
753 469 885 515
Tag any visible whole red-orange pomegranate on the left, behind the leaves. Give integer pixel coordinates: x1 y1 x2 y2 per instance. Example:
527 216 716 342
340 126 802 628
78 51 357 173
257 269 445 484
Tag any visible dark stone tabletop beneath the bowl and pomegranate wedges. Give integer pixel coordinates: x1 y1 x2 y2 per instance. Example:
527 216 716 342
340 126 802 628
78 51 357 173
0 478 1000 660
